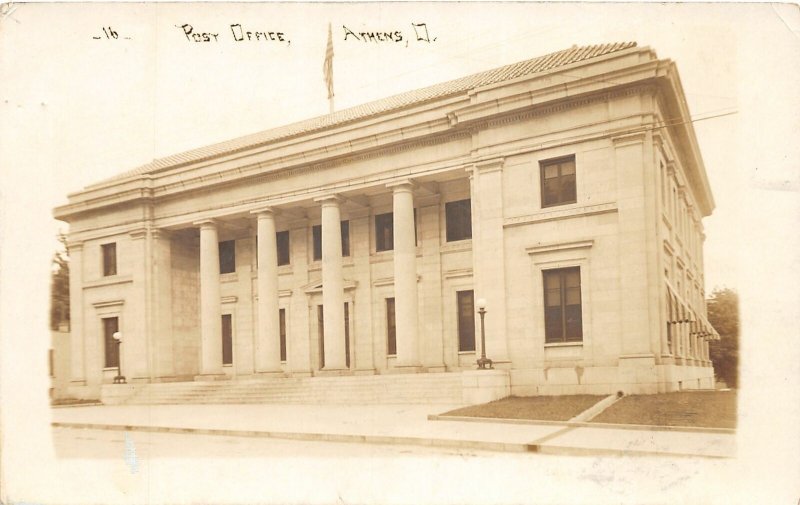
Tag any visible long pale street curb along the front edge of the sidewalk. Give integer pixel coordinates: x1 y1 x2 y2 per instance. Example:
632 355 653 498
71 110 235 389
50 422 728 459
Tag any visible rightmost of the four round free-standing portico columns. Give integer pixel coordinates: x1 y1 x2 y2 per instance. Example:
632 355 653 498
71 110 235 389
389 181 420 366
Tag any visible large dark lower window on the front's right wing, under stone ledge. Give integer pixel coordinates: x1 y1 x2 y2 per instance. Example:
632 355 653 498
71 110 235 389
542 267 583 343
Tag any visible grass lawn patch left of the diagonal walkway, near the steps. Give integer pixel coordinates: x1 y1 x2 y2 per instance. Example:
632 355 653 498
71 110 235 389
442 395 605 421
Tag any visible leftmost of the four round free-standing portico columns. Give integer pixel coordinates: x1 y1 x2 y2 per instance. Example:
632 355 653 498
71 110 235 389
196 220 222 375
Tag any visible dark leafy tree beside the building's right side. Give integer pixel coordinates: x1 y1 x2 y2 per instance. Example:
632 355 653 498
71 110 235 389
706 288 739 388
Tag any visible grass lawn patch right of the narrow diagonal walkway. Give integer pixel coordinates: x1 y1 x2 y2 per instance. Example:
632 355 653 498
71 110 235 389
591 391 736 428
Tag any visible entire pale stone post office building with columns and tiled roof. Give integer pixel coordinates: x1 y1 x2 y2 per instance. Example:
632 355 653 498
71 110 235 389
55 44 714 398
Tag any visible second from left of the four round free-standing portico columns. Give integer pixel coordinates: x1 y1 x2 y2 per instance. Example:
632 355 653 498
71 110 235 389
255 209 281 372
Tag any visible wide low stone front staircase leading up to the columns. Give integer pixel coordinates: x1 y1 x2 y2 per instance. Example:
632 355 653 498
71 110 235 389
106 372 463 405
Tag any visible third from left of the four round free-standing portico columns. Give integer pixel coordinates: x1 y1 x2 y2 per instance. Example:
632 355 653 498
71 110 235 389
317 196 346 370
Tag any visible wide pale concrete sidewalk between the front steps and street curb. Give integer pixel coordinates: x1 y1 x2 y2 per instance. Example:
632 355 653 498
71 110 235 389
52 404 736 458
